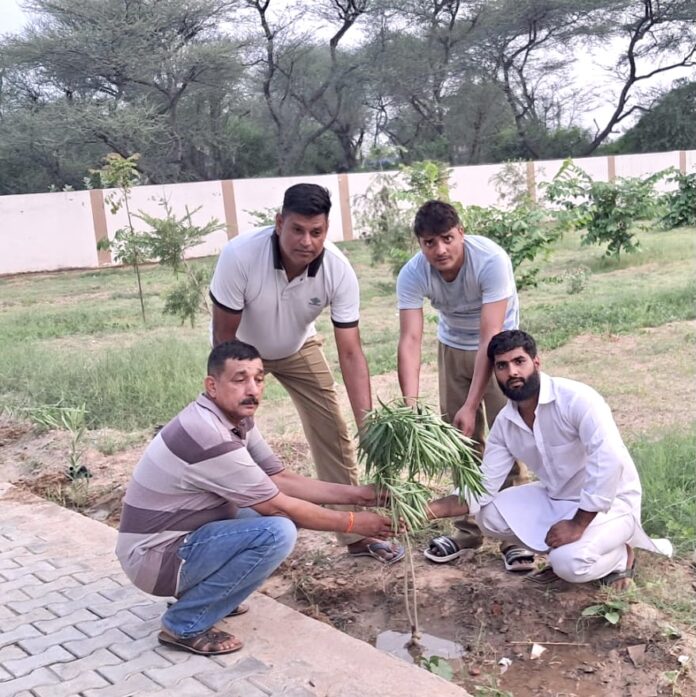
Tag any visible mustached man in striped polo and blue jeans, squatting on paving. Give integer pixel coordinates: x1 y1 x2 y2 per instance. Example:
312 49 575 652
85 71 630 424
116 341 393 655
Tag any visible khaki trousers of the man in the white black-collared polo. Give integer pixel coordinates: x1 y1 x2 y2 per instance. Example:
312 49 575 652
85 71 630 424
263 336 362 545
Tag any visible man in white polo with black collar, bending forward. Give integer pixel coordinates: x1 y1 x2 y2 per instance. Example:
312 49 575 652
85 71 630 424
210 184 403 563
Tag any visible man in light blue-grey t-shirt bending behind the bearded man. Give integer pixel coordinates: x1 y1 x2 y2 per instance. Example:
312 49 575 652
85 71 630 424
396 201 534 571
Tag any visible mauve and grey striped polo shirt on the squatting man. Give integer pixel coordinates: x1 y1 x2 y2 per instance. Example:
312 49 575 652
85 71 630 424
116 394 284 596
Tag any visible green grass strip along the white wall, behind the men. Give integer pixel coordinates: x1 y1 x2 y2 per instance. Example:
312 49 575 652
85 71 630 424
0 229 696 430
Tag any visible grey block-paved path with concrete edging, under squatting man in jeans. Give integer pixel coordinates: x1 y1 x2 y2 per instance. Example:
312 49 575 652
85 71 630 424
0 484 468 697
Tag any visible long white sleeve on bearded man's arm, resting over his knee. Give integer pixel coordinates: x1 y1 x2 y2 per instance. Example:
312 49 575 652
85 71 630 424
570 391 630 513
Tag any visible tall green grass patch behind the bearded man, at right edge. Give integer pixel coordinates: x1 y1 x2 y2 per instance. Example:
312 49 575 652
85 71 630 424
630 424 696 554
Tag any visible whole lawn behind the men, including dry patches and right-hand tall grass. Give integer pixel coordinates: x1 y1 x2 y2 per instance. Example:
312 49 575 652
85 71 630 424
0 228 696 552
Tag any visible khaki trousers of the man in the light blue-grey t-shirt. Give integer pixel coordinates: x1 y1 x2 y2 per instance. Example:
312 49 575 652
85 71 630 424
437 343 529 542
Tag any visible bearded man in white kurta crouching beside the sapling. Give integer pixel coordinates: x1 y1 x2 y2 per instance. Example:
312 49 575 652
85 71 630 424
436 330 672 588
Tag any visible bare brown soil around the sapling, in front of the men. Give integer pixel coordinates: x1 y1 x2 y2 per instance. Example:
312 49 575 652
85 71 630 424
262 532 696 697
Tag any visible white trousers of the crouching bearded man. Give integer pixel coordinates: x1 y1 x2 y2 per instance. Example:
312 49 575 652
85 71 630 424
476 502 635 583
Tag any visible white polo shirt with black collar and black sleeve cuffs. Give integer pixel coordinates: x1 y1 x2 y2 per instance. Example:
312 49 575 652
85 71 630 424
210 227 360 360
